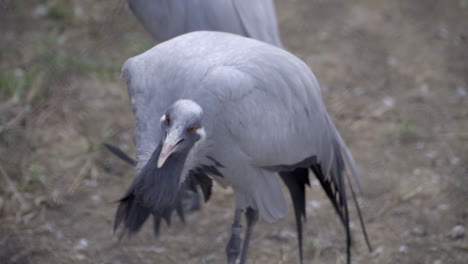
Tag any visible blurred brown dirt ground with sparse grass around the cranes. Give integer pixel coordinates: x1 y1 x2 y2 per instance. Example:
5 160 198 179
0 0 468 264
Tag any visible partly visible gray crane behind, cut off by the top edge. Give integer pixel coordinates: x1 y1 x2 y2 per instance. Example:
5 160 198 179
127 0 282 47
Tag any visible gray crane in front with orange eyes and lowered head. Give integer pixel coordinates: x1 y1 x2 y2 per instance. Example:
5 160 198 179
114 31 370 264
